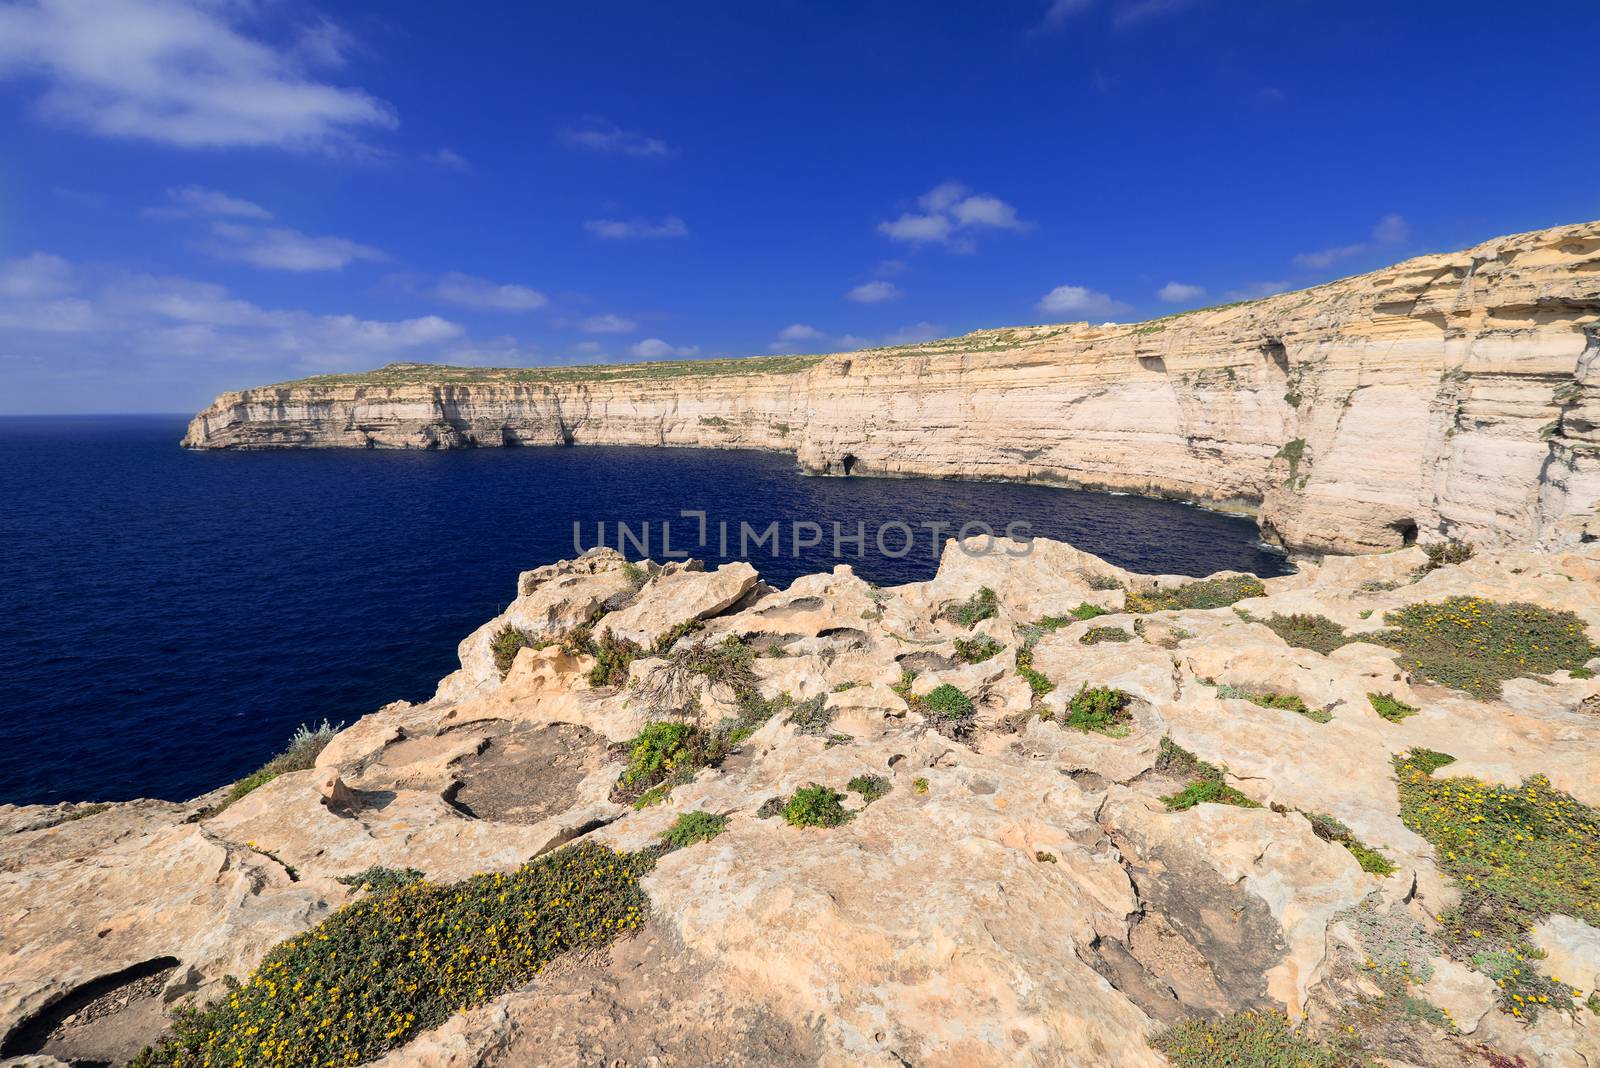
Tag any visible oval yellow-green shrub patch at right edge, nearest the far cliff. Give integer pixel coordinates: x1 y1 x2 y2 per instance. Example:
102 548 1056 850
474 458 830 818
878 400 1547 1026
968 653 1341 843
1370 596 1600 699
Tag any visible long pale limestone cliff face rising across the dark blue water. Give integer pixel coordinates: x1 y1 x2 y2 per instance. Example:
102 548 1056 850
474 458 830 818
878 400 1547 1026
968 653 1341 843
184 222 1600 552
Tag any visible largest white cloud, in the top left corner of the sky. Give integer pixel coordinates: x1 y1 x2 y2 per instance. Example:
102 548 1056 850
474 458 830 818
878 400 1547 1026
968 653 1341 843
0 0 397 149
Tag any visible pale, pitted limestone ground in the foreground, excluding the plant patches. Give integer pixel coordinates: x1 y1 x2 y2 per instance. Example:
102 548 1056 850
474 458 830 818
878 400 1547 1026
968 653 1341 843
0 540 1600 1068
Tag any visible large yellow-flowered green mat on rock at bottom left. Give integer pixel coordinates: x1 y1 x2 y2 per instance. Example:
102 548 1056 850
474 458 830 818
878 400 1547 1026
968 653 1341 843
133 843 654 1068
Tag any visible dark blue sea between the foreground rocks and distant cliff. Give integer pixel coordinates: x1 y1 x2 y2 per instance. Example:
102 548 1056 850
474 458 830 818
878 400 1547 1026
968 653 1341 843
0 416 1288 803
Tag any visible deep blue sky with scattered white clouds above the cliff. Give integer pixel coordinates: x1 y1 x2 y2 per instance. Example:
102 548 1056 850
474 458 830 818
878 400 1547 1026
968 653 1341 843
0 0 1600 412
